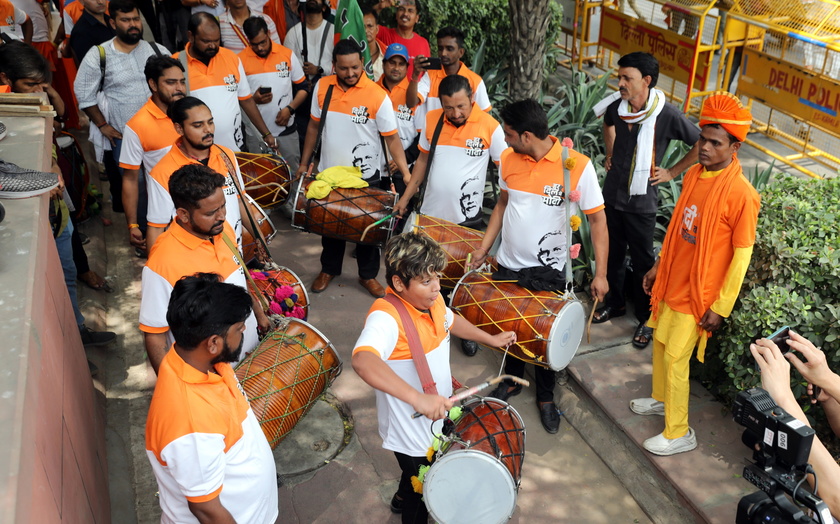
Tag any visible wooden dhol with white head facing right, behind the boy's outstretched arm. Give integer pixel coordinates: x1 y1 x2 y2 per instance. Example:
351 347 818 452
450 271 586 371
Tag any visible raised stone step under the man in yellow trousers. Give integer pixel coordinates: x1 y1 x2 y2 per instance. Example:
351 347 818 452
559 342 756 523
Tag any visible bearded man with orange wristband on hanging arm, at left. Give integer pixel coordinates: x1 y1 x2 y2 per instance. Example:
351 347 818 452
120 56 186 251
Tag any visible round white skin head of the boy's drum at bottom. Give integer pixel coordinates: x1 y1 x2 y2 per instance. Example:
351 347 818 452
423 449 516 524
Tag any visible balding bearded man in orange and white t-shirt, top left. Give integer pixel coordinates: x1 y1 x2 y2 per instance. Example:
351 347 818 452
174 12 277 151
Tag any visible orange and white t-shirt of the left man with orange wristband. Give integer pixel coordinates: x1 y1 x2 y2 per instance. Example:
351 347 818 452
120 98 179 173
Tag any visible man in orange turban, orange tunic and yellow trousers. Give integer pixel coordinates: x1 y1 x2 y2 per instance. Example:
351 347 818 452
630 91 760 455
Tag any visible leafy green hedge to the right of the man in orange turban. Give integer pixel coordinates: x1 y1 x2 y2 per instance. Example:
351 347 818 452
701 176 840 410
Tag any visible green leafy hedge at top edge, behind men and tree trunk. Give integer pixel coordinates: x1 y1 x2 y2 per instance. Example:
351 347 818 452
379 0 563 74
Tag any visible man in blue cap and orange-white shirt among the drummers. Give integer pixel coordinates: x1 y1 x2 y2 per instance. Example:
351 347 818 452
377 44 423 178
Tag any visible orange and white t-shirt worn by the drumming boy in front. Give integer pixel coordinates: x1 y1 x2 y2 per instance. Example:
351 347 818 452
353 287 454 457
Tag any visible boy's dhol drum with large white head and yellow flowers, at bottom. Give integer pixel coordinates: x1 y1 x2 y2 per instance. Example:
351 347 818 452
423 397 525 524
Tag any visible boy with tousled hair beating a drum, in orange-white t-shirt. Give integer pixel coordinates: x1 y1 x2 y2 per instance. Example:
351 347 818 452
352 233 516 524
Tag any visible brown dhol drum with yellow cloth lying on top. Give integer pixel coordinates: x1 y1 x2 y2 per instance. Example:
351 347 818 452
292 178 397 246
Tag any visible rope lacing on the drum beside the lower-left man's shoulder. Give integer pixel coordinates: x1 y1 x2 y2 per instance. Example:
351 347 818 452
236 330 341 445
